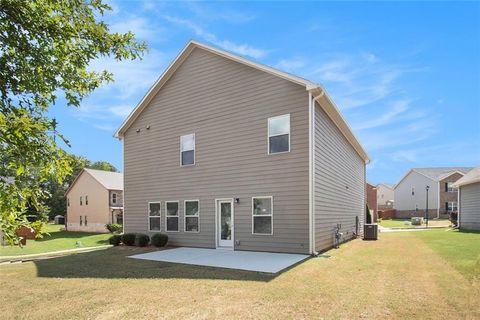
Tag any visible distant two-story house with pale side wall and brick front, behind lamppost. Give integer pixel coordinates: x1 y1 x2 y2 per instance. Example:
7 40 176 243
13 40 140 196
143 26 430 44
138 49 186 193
394 167 472 219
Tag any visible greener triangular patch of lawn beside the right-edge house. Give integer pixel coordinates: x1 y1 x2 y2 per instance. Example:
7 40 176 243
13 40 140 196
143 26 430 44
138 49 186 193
415 230 480 279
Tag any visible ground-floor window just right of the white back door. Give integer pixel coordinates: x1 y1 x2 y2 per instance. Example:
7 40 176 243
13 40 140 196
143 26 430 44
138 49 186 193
252 197 273 235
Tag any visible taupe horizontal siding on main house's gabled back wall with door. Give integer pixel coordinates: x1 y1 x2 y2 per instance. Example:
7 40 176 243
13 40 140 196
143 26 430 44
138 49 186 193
124 48 309 253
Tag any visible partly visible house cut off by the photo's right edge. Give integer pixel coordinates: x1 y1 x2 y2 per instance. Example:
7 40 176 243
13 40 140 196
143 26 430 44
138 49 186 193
454 167 480 230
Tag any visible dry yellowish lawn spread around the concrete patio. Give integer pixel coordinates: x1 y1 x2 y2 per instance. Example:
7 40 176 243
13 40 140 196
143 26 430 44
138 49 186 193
0 230 480 319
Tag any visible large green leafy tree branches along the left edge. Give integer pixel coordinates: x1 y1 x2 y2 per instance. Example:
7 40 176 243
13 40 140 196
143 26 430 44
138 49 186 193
0 0 146 244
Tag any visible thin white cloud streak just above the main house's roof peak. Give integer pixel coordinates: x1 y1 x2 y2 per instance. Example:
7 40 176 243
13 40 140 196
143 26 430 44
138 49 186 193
164 16 267 59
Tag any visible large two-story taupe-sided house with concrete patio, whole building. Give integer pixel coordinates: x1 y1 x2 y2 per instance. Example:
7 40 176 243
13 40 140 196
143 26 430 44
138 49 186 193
116 41 369 253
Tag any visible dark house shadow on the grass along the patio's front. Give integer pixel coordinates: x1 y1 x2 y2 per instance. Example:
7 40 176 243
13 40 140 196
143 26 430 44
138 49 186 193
34 247 296 282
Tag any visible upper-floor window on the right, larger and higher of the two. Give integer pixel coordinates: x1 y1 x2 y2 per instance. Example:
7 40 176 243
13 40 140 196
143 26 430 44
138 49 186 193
268 114 290 154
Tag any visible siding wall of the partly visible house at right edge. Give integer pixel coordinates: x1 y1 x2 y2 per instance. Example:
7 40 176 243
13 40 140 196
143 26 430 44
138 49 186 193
460 182 480 230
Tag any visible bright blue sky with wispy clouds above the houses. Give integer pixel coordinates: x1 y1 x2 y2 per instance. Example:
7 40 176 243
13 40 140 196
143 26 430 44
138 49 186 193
51 1 480 183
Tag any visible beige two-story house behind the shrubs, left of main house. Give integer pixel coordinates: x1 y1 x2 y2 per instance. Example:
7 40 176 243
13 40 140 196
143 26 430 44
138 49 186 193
65 169 123 232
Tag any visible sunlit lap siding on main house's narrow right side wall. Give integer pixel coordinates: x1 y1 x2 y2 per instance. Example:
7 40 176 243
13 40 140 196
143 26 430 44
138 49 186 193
314 104 365 251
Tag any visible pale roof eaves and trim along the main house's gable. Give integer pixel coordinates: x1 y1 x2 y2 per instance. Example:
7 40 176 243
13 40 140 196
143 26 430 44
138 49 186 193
114 40 370 163
